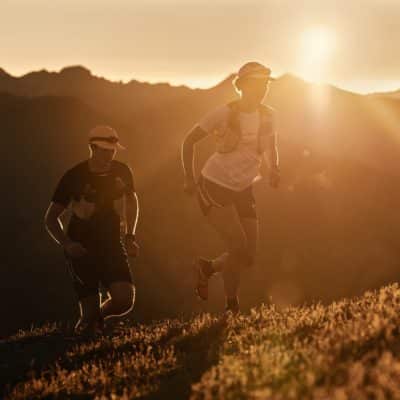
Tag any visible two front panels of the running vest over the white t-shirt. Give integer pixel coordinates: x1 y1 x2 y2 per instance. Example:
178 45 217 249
215 100 274 154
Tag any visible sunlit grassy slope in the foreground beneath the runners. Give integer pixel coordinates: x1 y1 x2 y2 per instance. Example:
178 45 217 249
0 284 400 400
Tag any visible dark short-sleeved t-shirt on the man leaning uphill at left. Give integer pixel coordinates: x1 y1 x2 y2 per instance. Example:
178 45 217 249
52 160 135 245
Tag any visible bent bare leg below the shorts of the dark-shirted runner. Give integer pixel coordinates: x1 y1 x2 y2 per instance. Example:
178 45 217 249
101 282 135 319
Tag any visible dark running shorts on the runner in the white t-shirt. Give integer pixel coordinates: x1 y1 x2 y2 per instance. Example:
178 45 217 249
197 175 257 219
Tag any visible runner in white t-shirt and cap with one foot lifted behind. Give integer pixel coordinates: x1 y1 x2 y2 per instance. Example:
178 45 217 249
182 62 280 313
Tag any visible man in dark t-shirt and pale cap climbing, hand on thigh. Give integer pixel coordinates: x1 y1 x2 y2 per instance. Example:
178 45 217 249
45 126 139 333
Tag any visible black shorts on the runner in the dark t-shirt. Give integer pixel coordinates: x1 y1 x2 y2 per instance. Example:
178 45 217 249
64 241 132 299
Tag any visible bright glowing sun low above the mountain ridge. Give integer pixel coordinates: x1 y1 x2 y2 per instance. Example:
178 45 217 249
299 26 336 82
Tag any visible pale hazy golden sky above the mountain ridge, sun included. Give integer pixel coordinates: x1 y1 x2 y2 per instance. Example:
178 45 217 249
0 0 400 92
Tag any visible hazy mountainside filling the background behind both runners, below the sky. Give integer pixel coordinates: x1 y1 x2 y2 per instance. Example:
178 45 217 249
0 67 400 334
